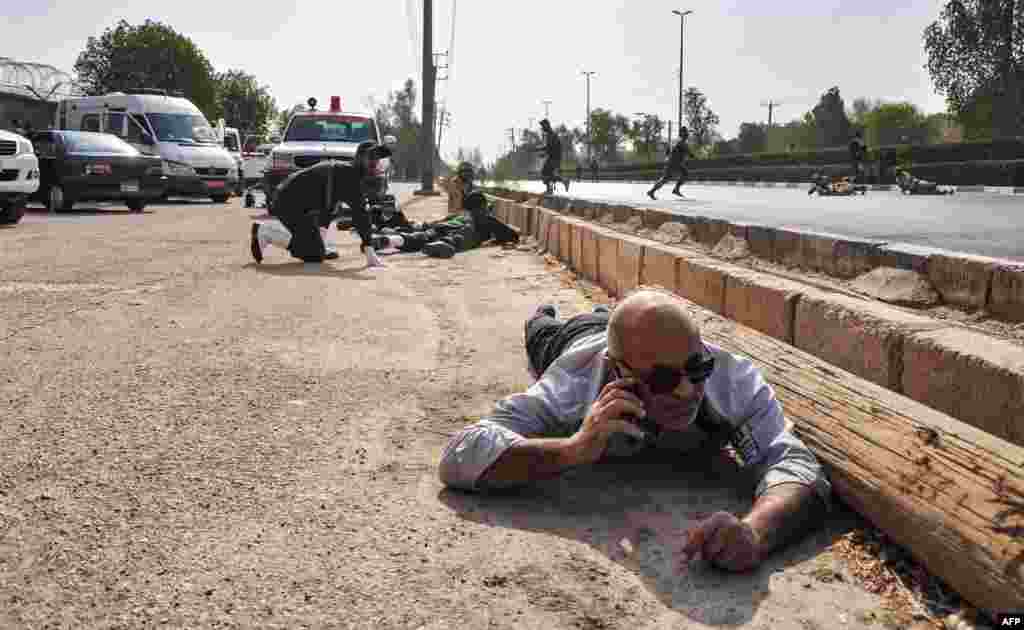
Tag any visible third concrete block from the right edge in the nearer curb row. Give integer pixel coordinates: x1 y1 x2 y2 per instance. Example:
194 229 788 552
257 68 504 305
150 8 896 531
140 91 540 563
722 267 811 344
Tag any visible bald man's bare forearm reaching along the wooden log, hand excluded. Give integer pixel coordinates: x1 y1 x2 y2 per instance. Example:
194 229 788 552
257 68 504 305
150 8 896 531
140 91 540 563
743 482 825 554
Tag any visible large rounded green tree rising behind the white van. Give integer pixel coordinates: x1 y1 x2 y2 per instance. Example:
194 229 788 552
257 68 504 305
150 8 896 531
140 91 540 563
75 19 218 119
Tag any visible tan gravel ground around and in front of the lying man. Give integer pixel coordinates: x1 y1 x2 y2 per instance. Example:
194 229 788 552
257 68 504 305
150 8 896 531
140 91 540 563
0 198 962 630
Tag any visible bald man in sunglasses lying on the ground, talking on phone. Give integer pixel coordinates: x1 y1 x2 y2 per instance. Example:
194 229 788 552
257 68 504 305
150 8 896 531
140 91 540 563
439 289 831 572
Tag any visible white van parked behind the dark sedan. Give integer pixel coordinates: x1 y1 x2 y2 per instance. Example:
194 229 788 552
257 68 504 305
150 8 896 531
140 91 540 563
55 89 239 203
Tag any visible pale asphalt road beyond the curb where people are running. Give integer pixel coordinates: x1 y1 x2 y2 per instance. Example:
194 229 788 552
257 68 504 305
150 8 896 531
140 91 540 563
507 181 1024 260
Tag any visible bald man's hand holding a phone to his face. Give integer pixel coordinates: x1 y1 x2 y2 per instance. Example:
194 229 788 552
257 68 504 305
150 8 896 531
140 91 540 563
569 379 646 465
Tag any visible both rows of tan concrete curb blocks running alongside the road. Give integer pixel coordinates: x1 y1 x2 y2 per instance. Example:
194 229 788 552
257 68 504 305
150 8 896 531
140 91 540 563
483 189 1024 446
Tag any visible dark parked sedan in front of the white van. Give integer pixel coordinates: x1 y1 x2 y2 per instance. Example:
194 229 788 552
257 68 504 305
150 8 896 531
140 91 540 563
30 130 168 212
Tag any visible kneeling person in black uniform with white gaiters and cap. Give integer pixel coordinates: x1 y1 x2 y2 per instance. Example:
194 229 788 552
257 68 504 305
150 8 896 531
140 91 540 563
251 142 391 267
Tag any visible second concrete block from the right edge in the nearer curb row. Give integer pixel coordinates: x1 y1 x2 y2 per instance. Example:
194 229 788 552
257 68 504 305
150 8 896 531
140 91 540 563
794 291 947 391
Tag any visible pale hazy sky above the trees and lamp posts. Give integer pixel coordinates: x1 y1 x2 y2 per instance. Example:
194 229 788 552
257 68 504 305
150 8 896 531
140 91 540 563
8 0 944 160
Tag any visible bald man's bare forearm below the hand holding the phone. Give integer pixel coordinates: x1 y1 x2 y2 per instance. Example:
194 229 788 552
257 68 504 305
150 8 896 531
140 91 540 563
477 437 577 488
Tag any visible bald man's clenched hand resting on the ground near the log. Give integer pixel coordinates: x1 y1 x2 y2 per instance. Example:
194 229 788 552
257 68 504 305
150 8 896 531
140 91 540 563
680 512 764 572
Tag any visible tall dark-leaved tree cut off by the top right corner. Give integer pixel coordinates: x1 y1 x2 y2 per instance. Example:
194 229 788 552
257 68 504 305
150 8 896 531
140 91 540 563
924 0 1024 137
